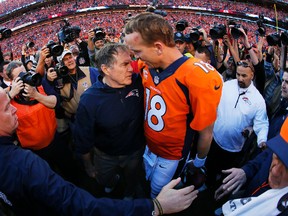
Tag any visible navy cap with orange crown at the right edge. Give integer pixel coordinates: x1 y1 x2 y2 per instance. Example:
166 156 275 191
267 117 288 168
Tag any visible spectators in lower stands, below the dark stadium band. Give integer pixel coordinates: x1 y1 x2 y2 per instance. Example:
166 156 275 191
1 11 275 59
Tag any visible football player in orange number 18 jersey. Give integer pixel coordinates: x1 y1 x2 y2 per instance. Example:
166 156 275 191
124 12 222 197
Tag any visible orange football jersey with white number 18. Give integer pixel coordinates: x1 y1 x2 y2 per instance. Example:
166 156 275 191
138 56 223 160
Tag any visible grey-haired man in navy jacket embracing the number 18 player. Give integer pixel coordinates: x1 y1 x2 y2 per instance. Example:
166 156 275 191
73 44 145 198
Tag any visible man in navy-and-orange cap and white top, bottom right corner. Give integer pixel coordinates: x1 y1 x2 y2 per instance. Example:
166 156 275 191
218 118 288 215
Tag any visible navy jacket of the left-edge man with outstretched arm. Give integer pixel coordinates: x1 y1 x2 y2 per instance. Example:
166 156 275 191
0 137 154 216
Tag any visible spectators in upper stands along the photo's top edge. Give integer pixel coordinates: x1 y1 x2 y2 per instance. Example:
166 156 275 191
0 0 286 23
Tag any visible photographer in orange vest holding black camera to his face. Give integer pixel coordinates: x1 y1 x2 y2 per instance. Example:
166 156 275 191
6 61 79 184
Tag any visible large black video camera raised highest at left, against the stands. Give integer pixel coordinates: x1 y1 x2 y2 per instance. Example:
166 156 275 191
57 19 81 43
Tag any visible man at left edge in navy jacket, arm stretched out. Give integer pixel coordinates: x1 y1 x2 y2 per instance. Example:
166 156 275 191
0 88 197 216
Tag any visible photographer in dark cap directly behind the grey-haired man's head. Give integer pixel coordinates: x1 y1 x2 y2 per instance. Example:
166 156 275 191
88 28 105 67
